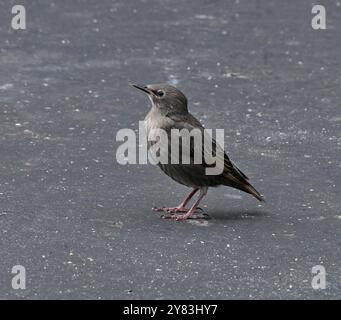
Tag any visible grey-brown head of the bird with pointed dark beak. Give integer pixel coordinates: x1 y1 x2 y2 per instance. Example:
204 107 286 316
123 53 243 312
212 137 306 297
132 84 188 115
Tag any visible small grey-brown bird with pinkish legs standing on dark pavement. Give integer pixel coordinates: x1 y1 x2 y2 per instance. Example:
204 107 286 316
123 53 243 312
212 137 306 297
131 83 265 221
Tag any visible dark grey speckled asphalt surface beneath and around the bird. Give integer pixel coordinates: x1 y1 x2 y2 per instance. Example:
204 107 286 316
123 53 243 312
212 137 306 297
0 0 341 299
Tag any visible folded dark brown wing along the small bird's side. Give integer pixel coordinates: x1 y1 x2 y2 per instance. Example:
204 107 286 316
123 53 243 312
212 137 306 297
165 114 248 182
